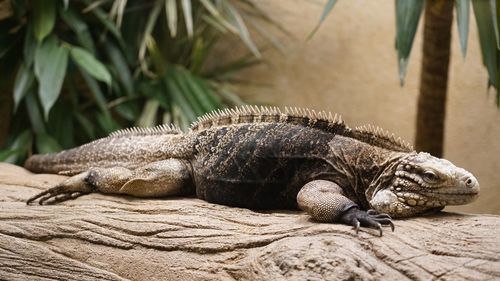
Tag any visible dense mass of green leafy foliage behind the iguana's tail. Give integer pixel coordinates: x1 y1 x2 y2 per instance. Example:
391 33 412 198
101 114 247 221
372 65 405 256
0 0 279 162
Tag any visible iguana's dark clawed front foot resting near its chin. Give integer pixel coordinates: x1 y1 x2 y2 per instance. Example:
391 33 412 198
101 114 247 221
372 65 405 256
341 207 394 236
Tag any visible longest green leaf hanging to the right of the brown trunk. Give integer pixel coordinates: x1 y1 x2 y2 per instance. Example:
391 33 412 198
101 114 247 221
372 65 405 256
472 0 498 89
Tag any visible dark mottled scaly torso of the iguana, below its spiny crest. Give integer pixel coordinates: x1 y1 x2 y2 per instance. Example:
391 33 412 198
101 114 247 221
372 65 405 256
193 120 404 209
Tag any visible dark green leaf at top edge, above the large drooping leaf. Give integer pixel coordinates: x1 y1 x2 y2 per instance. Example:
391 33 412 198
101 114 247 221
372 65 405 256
33 0 56 42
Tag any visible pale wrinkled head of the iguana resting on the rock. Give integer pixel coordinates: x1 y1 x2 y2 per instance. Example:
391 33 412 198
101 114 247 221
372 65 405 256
370 152 479 217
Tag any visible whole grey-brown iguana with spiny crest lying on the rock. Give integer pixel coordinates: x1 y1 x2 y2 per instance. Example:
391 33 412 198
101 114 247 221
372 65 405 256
25 106 479 235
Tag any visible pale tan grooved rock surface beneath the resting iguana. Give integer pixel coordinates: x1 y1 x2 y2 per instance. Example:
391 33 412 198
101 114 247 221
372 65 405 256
0 163 500 280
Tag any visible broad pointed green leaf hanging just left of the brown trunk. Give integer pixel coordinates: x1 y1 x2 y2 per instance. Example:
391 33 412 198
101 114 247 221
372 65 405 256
396 0 424 86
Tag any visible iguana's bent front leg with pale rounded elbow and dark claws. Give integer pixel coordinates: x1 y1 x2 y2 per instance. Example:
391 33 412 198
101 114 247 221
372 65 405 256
297 180 394 236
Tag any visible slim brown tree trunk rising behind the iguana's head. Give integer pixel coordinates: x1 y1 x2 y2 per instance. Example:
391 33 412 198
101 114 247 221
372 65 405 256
415 0 454 157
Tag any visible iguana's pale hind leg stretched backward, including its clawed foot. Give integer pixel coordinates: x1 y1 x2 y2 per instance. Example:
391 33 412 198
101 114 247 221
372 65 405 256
26 159 191 205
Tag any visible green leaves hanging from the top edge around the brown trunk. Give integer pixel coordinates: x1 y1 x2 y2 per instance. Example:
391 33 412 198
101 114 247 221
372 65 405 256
313 0 500 103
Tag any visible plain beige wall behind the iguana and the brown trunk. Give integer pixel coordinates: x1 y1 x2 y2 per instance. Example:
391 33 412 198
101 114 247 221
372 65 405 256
235 0 500 214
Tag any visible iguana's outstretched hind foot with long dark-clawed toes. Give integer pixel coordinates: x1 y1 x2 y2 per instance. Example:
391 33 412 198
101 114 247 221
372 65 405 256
26 173 94 205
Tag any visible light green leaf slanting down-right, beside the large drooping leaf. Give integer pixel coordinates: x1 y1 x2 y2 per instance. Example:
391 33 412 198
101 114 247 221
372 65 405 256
70 47 111 86
